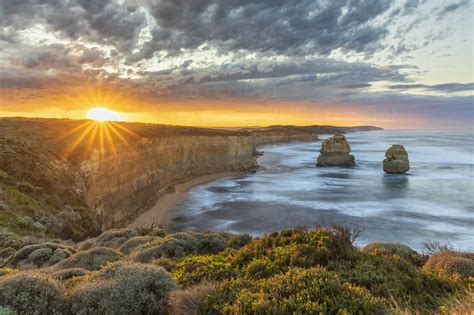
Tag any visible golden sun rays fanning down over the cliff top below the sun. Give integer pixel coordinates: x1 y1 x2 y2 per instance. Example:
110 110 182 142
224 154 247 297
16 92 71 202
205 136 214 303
57 120 139 158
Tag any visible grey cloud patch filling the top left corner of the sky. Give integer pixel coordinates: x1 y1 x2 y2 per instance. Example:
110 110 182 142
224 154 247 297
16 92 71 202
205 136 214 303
0 0 145 52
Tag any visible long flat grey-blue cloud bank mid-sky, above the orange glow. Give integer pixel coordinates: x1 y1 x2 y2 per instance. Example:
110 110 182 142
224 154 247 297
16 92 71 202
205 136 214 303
131 57 407 100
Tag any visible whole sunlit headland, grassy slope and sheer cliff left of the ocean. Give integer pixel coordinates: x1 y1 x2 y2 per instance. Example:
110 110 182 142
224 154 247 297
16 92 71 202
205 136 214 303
0 118 257 240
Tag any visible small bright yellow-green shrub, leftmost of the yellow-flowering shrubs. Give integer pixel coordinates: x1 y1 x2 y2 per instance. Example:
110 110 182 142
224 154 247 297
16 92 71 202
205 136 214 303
172 255 237 287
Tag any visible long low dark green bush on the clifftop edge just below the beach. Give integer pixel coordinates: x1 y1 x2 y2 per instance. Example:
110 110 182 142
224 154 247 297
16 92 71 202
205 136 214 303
133 233 227 263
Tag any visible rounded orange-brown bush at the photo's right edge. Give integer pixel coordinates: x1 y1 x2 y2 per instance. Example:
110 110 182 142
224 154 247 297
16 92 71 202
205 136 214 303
423 250 474 277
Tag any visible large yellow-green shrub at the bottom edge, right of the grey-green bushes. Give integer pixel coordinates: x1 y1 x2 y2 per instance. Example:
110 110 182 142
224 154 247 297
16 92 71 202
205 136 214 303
206 267 386 315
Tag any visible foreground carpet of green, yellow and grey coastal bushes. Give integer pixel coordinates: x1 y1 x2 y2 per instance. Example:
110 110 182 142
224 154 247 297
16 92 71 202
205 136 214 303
0 226 474 314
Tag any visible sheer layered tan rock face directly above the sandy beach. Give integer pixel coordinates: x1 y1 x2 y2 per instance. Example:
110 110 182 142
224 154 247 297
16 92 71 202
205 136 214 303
80 135 257 228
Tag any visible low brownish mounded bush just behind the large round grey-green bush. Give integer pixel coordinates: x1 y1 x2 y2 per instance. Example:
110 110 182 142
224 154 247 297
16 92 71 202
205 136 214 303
54 247 123 270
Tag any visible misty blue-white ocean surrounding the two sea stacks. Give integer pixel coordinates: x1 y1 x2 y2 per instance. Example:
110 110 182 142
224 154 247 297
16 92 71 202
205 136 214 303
169 130 474 251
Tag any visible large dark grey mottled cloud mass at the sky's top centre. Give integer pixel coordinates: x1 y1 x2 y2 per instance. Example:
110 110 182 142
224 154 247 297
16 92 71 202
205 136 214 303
141 0 390 57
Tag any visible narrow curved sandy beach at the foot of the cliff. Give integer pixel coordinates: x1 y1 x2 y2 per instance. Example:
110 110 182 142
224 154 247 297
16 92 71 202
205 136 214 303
128 172 239 228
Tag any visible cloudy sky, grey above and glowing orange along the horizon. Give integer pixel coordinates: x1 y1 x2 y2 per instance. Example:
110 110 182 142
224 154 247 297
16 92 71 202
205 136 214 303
0 0 474 129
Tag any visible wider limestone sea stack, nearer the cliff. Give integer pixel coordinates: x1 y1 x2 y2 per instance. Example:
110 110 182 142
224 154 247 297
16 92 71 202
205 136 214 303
316 134 355 167
